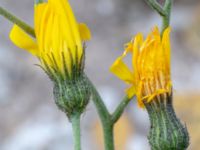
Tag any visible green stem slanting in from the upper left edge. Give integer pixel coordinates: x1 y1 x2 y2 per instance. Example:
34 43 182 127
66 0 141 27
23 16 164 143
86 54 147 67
0 6 35 37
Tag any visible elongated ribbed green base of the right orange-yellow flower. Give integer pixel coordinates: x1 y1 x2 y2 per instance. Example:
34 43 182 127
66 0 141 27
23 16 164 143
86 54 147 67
145 94 189 150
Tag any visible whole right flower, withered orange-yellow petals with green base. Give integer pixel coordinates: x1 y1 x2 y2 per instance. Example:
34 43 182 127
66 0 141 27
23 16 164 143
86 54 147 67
111 27 189 150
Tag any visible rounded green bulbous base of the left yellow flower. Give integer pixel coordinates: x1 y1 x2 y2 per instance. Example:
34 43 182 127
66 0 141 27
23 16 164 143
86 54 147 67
53 75 90 118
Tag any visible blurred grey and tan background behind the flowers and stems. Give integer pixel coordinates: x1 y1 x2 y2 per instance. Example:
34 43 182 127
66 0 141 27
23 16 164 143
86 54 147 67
0 0 200 150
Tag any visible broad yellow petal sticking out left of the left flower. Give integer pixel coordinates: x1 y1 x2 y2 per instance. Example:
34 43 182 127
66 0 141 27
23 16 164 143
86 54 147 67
10 25 38 56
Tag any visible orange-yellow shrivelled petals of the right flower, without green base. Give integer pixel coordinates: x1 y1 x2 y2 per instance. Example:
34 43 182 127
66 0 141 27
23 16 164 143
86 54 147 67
111 27 172 107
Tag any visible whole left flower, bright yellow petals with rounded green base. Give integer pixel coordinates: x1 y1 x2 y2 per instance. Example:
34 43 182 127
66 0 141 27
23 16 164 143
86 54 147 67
10 0 91 117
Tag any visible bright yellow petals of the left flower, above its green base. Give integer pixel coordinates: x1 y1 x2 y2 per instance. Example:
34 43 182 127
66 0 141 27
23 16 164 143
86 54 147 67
10 0 91 77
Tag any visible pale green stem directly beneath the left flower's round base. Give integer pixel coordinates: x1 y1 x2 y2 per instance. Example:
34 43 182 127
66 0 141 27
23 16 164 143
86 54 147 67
71 113 81 150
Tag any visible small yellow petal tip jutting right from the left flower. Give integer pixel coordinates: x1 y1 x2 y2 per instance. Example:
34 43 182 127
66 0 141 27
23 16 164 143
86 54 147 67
79 23 91 41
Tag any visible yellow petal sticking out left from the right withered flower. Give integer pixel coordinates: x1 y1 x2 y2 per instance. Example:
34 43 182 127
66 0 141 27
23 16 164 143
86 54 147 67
110 57 134 83
